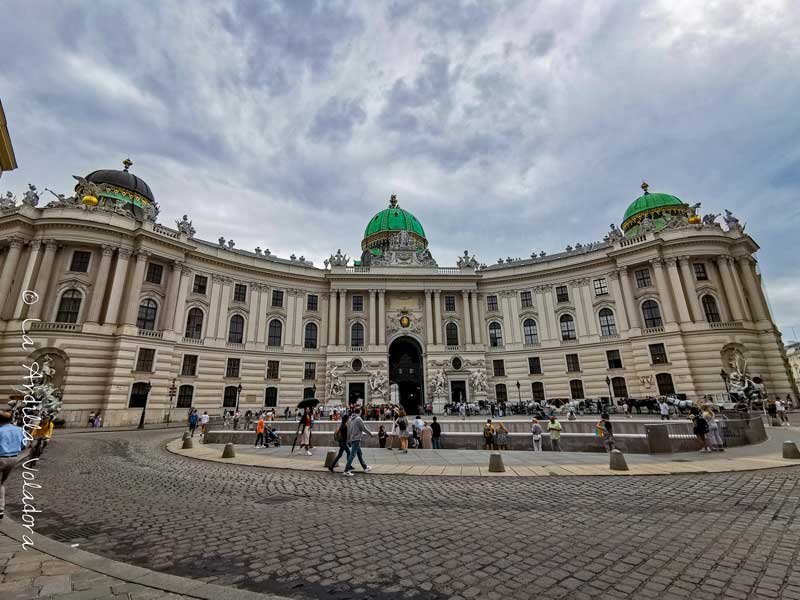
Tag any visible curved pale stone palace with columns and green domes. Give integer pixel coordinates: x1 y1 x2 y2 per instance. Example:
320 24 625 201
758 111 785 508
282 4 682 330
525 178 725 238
0 161 794 425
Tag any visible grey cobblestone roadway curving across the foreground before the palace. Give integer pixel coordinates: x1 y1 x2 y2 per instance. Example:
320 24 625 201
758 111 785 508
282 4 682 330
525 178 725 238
8 431 800 600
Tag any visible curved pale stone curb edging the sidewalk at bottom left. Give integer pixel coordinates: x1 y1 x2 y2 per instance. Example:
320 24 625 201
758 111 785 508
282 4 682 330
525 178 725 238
0 515 291 600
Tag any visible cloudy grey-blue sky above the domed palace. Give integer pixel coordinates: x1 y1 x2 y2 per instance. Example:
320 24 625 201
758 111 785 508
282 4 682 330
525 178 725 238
0 0 800 338
